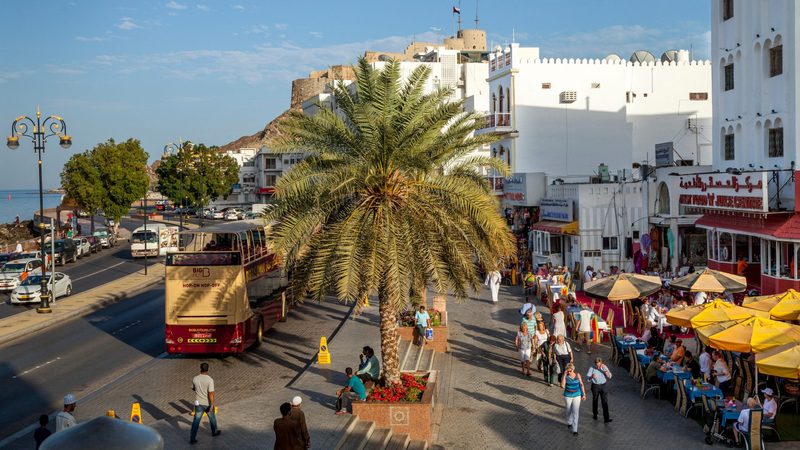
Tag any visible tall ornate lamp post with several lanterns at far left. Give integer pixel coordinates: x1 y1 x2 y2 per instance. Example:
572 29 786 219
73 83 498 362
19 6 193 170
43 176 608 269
6 106 72 314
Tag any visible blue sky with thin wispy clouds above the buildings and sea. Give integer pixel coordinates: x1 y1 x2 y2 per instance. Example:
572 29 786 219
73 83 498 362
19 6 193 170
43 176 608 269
0 0 710 189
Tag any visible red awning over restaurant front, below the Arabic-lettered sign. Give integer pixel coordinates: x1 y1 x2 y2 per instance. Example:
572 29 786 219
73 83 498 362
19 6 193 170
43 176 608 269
695 213 800 240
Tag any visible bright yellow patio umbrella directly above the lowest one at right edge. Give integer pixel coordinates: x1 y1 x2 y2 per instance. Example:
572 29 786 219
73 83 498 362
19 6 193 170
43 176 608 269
709 317 800 353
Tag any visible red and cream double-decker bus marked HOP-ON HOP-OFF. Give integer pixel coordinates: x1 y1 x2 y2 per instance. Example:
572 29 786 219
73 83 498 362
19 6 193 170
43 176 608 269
165 220 291 353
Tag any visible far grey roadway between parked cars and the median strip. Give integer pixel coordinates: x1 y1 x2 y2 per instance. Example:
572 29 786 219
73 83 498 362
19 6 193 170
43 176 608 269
0 220 152 318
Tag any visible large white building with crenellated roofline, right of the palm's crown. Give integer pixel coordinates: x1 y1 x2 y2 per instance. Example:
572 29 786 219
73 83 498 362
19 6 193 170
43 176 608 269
484 44 712 206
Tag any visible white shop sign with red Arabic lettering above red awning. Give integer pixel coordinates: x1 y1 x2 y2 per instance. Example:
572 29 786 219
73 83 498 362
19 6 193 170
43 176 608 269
678 172 769 212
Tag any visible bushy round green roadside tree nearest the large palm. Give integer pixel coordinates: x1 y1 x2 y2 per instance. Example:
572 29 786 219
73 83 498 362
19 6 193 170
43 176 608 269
156 143 239 207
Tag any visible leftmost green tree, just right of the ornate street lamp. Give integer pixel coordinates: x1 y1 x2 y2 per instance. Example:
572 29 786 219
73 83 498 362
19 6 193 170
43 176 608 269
61 151 104 233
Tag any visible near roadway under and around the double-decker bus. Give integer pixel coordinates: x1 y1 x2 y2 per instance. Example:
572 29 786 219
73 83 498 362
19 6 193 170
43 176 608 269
0 284 349 448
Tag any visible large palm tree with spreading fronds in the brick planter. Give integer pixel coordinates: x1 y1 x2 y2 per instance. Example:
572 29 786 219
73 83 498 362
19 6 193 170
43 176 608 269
271 58 514 383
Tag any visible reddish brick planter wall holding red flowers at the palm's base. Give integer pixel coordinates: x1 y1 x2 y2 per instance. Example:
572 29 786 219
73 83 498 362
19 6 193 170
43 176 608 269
353 370 438 442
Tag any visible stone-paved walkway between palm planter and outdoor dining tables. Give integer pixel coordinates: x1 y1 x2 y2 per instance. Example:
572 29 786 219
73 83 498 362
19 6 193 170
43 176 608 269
437 287 706 449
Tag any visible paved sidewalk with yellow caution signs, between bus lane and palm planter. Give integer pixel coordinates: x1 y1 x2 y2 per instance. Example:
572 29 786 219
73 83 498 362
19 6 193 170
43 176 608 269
151 306 380 449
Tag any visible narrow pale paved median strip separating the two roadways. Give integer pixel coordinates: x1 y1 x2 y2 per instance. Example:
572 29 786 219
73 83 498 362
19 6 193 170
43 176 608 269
0 263 164 344
